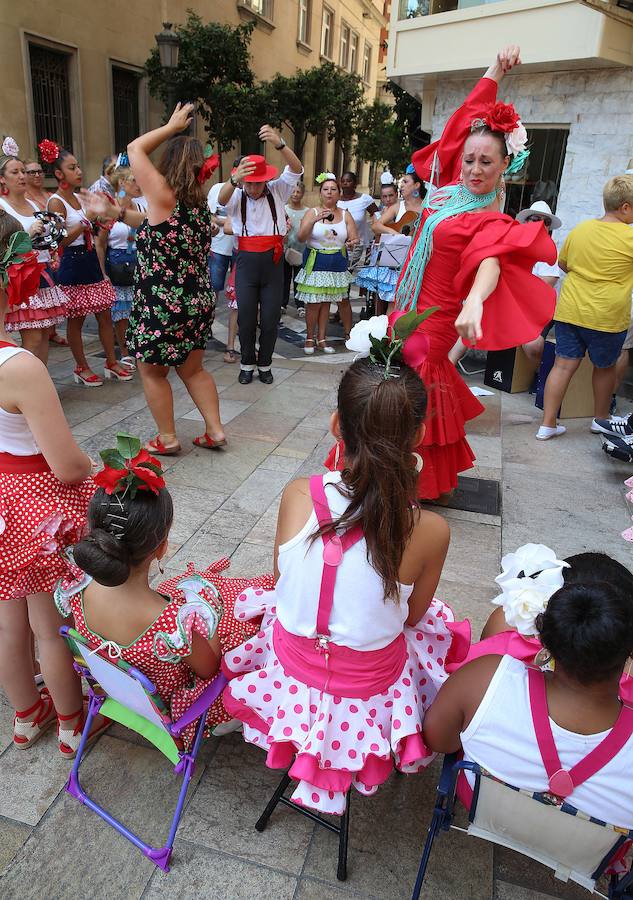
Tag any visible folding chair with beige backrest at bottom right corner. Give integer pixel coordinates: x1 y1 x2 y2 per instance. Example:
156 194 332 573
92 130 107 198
412 753 633 900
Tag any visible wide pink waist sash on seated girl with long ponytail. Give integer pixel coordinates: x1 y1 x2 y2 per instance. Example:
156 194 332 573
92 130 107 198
273 620 407 700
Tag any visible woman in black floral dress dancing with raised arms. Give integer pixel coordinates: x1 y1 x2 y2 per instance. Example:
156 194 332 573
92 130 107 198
127 104 226 455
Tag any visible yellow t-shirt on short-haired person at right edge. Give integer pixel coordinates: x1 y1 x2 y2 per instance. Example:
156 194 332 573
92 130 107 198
554 219 633 332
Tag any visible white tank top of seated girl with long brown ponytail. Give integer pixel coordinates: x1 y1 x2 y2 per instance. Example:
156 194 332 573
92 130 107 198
275 472 413 650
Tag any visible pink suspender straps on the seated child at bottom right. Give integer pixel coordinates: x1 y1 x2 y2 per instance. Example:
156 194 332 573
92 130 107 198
528 668 633 799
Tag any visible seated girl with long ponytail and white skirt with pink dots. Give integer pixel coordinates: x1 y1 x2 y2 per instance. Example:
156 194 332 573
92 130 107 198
223 358 460 815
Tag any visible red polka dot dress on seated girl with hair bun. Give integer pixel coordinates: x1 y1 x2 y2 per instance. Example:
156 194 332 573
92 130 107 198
55 559 274 747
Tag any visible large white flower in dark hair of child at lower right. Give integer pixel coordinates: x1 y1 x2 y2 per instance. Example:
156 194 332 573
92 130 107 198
492 544 569 635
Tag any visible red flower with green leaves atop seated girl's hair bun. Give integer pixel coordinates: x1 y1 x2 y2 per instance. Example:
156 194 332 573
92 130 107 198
94 432 165 499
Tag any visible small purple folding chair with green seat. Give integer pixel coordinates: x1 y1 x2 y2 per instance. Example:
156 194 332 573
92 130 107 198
60 625 227 872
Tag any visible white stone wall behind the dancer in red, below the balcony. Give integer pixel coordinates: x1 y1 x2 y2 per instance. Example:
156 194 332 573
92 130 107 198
433 69 633 243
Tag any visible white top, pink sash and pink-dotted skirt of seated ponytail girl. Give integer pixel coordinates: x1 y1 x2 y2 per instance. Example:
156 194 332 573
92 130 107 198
223 473 454 815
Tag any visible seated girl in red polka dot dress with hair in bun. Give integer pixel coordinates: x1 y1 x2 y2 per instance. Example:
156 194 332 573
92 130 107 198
55 448 272 746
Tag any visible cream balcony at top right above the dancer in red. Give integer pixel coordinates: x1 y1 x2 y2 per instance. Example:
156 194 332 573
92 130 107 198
387 0 633 98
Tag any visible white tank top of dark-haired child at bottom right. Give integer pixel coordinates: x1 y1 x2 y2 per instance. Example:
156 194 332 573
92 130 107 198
461 656 633 828
